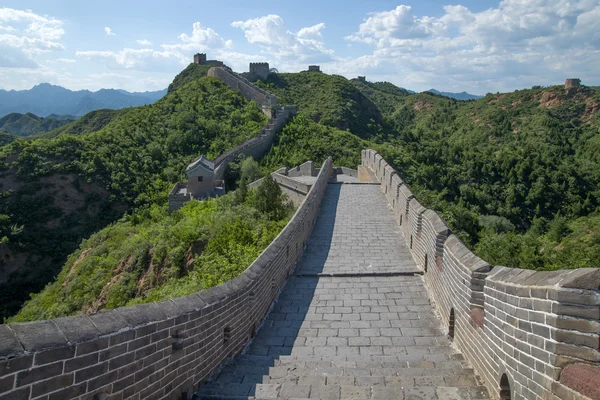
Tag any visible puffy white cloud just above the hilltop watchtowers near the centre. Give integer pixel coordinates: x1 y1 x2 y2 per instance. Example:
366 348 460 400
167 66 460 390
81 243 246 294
231 14 333 62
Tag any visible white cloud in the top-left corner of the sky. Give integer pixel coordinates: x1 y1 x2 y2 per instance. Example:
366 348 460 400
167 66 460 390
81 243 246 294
0 7 65 68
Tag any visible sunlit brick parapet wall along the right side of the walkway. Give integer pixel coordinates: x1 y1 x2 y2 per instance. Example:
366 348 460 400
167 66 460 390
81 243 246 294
362 150 600 400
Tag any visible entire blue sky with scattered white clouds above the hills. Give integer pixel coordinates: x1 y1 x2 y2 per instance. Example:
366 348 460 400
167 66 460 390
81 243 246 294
0 0 600 94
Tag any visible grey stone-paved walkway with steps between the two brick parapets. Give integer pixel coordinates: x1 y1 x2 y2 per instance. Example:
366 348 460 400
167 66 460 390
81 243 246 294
198 184 488 400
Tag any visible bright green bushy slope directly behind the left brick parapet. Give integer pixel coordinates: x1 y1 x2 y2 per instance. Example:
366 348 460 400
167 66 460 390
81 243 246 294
11 166 292 321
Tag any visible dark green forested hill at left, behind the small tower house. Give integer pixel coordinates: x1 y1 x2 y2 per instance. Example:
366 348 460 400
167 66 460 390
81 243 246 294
0 74 266 316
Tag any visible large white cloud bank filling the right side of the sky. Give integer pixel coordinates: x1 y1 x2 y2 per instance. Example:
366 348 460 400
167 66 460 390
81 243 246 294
342 0 600 93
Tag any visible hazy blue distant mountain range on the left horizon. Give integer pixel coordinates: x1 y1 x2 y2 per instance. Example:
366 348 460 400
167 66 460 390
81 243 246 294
0 83 167 117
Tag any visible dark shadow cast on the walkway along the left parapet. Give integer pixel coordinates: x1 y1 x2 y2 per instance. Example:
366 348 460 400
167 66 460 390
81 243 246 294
192 184 343 399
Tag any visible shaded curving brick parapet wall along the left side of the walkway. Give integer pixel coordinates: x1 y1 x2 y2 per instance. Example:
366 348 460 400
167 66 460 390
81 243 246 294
0 159 332 400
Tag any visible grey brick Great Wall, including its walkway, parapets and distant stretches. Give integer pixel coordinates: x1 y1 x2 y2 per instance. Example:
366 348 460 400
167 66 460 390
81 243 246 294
0 59 600 400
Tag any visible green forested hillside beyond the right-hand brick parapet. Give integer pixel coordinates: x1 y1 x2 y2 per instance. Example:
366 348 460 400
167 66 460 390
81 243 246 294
253 73 600 269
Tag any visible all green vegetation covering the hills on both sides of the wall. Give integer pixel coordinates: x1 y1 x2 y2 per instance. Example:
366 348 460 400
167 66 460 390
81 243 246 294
0 64 600 320
